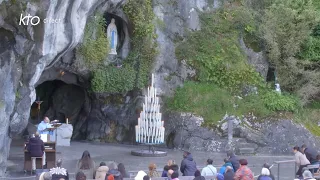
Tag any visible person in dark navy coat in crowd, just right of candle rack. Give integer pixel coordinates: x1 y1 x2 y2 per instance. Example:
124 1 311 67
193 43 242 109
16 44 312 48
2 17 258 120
180 151 197 176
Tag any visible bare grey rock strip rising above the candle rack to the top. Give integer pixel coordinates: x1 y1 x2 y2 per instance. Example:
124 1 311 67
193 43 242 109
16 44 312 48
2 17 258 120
153 0 221 95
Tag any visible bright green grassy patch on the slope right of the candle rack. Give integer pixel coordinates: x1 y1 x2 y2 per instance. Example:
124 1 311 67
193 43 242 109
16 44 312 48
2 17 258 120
167 82 271 123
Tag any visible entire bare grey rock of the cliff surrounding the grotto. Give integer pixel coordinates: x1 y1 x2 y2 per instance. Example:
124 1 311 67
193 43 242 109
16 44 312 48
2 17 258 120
0 0 318 177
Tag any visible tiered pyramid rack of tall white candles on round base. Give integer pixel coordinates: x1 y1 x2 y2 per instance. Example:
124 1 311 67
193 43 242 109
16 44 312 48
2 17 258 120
131 74 167 157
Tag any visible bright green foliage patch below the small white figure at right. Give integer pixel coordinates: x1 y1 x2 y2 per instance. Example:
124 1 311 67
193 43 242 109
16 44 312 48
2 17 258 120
262 91 300 112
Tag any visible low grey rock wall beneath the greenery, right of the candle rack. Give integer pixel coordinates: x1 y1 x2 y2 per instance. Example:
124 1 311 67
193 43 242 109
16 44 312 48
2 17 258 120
165 112 320 155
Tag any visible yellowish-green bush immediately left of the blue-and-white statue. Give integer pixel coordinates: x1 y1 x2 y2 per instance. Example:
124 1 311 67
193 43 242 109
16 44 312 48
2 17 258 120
79 15 110 69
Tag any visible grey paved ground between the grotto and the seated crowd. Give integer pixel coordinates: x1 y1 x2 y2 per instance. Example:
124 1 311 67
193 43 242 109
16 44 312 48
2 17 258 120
0 140 295 180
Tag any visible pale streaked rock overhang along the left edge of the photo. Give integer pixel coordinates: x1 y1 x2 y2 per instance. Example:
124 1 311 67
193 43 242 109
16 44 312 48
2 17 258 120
0 0 124 176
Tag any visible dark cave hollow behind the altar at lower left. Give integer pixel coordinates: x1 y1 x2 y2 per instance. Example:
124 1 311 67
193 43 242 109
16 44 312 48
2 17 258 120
30 80 86 124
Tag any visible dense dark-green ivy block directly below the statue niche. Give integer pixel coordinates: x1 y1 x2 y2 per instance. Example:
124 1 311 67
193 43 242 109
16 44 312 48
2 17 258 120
91 65 135 93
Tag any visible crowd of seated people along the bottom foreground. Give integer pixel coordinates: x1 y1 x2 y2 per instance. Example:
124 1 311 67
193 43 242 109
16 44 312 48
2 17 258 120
35 145 320 180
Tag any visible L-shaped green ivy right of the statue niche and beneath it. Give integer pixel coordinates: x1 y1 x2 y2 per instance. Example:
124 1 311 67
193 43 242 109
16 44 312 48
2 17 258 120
91 0 157 93
